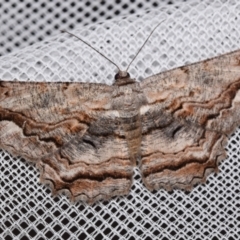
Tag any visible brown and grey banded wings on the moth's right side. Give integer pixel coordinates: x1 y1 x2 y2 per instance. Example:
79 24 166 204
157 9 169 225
140 51 240 190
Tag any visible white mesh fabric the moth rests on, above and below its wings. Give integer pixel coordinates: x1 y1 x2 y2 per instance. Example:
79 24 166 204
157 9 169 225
0 0 240 240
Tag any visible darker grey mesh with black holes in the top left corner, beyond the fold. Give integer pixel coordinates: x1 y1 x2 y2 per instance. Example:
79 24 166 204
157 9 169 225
0 0 169 56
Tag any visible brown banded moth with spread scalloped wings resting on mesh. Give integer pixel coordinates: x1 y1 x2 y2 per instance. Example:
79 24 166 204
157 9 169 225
0 24 240 204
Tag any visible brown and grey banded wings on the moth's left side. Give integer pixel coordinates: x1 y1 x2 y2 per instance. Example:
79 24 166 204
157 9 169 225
0 82 132 203
